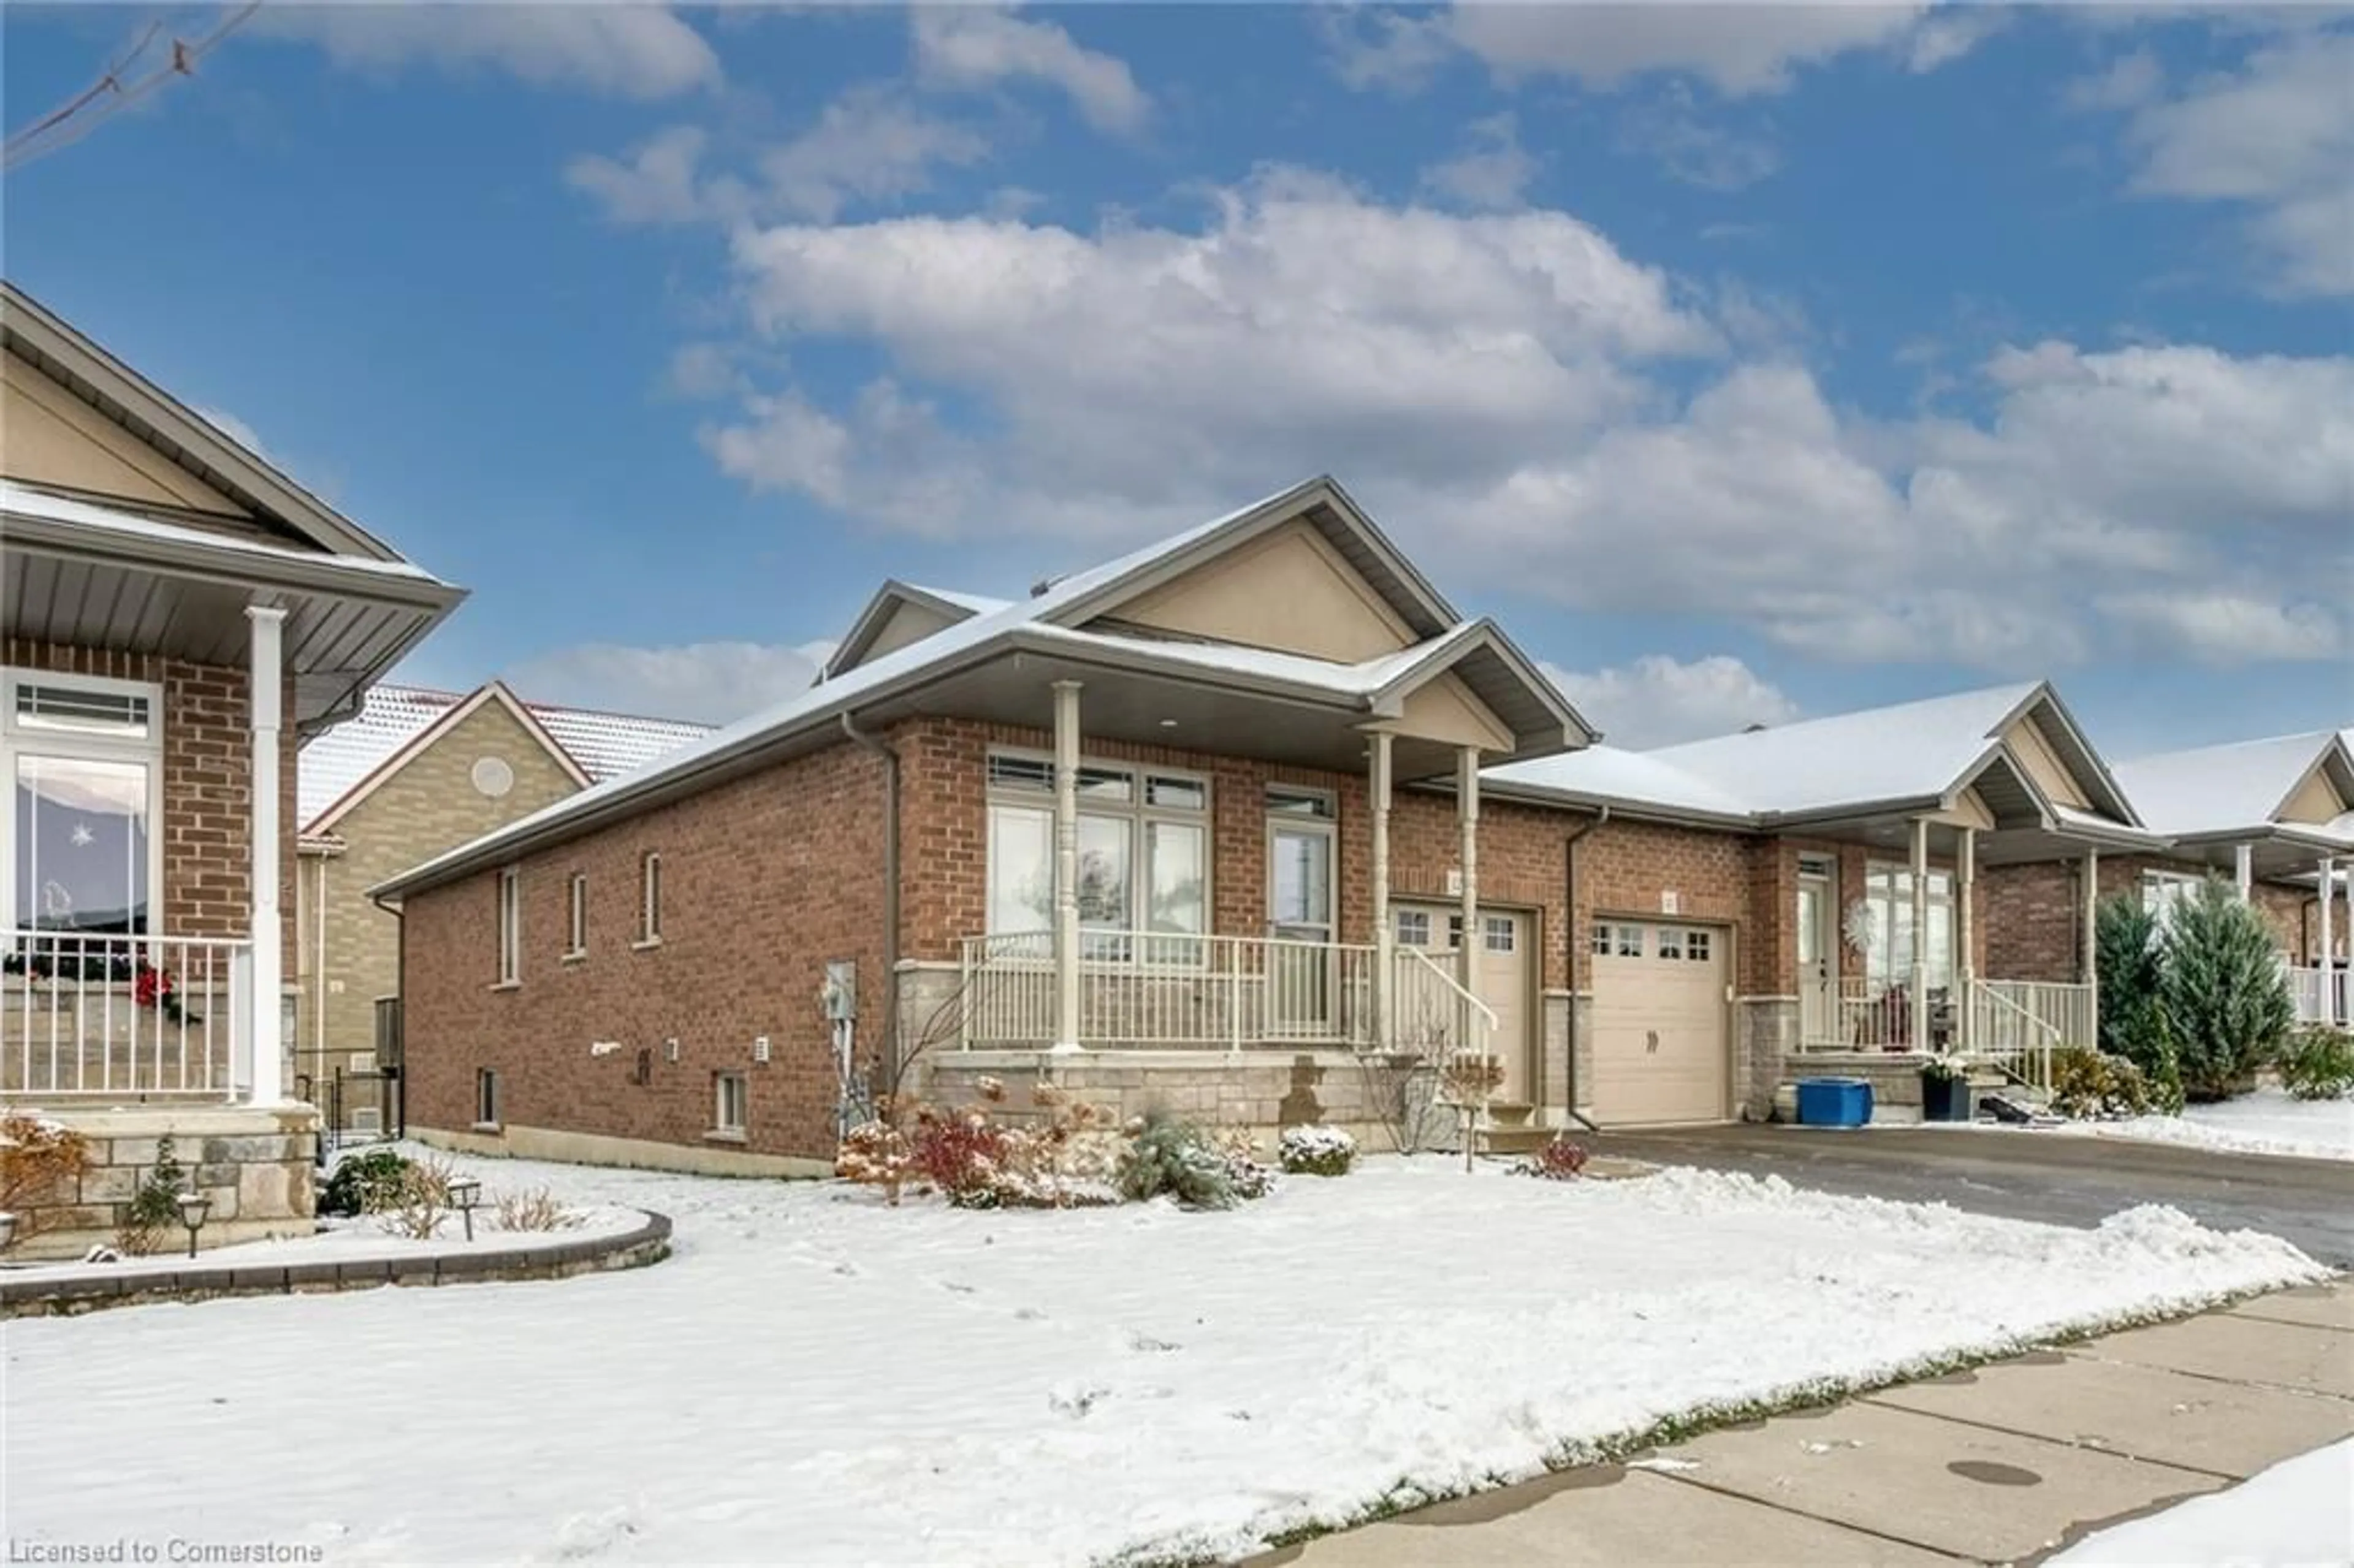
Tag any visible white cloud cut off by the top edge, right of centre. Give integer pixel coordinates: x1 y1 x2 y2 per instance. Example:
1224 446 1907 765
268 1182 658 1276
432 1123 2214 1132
1328 0 1996 96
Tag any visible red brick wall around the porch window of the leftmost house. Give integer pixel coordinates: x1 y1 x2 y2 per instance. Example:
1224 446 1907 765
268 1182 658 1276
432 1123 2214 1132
0 638 297 942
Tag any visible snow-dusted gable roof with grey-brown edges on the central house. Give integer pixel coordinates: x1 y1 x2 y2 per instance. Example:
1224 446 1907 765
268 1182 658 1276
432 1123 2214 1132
375 476 1594 895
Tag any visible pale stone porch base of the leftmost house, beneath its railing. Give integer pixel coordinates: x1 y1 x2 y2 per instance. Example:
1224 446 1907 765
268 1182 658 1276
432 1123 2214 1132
9 1104 318 1262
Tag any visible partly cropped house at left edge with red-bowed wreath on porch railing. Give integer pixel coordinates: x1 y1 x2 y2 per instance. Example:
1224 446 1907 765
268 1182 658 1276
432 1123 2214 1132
0 285 463 1252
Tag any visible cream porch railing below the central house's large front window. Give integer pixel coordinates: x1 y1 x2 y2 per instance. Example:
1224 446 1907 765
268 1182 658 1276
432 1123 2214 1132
961 927 1375 1050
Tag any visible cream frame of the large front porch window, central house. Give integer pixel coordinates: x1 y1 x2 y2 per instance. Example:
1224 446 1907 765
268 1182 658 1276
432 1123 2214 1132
981 747 1217 951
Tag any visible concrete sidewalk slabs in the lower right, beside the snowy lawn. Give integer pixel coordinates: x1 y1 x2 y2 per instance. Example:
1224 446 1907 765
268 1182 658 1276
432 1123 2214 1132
1252 1281 2354 1568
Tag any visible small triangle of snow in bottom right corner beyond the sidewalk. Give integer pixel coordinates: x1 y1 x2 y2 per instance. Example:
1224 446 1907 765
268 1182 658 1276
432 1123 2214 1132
2051 1439 2354 1568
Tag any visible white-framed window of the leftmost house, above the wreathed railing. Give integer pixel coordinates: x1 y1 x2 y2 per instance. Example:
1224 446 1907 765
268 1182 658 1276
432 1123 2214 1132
0 671 162 937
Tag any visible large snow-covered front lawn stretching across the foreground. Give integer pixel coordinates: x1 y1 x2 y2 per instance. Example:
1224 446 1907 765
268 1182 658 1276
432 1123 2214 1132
0 1161 2323 1563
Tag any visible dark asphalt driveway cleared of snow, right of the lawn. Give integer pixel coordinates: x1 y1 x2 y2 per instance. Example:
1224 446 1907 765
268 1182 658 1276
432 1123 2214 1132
1580 1125 2354 1269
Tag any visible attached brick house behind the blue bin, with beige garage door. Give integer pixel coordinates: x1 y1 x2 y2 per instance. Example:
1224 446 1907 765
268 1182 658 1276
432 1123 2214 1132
1483 683 2149 1125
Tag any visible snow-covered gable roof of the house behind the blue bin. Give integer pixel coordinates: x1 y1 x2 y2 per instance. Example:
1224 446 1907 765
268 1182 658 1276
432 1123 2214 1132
1483 680 2138 829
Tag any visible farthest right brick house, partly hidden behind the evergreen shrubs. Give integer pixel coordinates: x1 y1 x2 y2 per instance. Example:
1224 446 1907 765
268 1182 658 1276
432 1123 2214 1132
1989 730 2354 1022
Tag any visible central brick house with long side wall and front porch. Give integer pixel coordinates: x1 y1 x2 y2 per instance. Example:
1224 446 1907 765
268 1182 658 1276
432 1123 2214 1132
376 481 1591 1170
